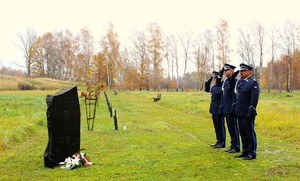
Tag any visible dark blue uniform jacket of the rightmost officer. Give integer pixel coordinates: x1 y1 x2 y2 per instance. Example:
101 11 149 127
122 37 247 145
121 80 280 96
235 77 260 117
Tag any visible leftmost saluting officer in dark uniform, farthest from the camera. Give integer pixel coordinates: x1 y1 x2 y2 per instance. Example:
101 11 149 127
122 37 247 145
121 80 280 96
205 71 226 148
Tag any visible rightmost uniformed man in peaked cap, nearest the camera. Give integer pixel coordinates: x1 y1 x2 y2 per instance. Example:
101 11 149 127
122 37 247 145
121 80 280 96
235 63 260 160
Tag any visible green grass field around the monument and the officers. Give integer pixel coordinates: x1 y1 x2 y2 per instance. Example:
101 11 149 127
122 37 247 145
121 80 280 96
0 86 300 180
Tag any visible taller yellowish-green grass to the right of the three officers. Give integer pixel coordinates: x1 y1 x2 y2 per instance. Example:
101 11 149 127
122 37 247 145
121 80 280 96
257 92 300 143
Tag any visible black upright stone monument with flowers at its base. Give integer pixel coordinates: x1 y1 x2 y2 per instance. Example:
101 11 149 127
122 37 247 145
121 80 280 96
44 86 80 168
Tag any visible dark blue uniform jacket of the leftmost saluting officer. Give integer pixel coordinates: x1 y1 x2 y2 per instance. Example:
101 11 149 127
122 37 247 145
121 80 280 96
205 79 222 114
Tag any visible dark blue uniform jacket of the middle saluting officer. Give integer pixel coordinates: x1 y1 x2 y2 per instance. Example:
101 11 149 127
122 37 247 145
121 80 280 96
219 77 237 114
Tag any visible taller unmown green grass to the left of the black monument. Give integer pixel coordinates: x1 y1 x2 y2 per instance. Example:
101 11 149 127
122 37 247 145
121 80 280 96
0 91 46 148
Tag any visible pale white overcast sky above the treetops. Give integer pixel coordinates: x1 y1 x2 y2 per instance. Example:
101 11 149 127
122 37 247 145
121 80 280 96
0 0 300 72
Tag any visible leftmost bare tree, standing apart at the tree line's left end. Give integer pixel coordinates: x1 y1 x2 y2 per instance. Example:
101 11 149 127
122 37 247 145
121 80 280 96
16 29 37 77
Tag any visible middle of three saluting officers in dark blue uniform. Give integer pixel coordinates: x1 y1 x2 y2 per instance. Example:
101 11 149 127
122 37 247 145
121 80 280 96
220 64 240 153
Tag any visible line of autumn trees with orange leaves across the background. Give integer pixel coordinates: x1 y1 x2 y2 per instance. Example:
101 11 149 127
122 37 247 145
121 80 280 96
18 19 300 92
